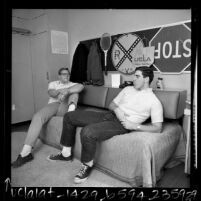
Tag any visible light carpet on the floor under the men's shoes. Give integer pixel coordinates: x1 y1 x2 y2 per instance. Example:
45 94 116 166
11 132 131 188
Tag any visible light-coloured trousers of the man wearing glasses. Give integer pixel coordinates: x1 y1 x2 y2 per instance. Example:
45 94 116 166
24 94 78 147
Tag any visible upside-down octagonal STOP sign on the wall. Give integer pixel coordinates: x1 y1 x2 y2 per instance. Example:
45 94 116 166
149 24 191 73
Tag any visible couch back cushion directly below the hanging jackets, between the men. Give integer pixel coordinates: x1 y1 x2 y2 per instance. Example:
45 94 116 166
78 85 108 108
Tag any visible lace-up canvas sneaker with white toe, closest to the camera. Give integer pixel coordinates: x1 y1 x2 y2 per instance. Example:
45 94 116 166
74 164 93 184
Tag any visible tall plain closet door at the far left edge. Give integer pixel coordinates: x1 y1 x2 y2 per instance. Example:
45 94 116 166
11 33 34 123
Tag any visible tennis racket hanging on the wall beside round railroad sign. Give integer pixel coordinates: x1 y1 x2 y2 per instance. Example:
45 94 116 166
100 33 112 75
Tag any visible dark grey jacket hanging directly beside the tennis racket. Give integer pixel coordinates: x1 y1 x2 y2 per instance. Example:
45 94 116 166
87 41 104 86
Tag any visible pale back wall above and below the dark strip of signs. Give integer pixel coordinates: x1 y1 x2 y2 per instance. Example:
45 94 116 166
63 9 191 99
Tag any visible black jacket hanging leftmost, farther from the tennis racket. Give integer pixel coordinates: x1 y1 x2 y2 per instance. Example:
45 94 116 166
70 43 89 83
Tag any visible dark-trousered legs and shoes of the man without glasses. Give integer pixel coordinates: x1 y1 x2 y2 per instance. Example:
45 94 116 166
49 110 128 183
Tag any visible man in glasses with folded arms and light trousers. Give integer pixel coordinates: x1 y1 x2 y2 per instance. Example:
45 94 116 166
12 68 84 168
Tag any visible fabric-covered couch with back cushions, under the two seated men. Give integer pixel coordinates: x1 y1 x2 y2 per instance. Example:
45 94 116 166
40 85 186 187
